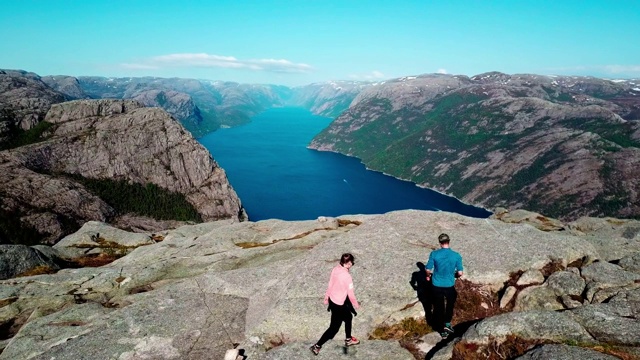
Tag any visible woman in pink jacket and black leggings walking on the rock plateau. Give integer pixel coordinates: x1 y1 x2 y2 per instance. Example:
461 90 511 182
310 253 360 355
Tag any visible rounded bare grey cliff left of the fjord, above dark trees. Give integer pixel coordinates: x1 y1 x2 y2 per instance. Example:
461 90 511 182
0 100 246 242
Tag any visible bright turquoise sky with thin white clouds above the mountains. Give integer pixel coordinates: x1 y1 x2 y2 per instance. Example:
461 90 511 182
0 0 640 86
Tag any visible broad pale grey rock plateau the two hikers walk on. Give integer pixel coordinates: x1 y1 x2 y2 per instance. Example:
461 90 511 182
0 210 640 360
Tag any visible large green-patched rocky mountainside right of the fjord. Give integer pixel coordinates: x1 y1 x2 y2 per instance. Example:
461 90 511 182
310 73 640 219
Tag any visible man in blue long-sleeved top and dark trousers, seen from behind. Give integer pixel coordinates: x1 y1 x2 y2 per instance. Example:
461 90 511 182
425 234 464 338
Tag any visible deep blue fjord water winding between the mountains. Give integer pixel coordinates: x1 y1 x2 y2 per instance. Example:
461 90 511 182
198 108 490 221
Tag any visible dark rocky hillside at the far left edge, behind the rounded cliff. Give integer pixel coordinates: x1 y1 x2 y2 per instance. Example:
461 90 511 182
0 70 68 143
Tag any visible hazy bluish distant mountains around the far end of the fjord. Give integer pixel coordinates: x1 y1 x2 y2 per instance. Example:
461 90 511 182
41 76 367 137
